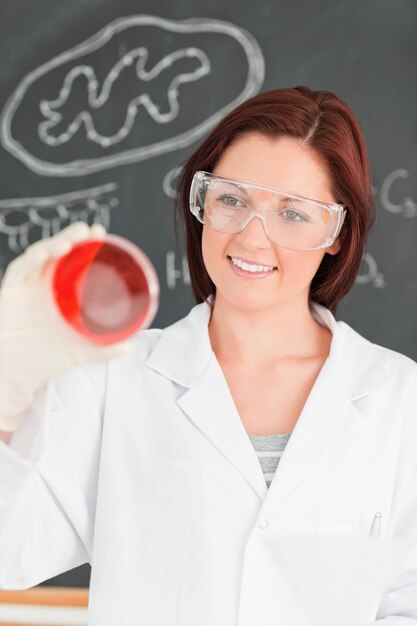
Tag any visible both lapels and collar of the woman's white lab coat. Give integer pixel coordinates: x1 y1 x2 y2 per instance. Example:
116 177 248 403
147 302 391 500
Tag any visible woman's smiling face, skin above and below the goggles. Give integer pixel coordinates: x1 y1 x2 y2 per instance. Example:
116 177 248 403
202 133 340 310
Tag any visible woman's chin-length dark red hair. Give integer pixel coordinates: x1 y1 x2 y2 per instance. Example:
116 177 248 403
177 87 374 312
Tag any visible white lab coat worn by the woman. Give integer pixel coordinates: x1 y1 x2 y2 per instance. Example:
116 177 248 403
0 303 417 626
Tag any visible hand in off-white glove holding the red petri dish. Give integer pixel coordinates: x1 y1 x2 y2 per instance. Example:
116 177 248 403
0 222 129 432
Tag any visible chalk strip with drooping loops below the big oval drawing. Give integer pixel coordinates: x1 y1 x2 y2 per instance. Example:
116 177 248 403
0 183 119 253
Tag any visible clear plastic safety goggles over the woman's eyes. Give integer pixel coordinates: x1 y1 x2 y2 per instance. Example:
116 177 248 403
190 172 346 250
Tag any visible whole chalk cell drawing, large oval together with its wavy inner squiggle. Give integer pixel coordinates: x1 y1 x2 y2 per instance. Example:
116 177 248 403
0 15 265 177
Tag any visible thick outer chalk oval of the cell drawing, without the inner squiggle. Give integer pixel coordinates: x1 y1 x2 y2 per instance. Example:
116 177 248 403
0 15 265 177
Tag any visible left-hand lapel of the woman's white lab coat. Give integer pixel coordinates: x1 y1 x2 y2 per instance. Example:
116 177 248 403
146 299 267 500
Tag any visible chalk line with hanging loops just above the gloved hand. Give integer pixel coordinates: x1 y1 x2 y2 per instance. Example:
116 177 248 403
0 183 119 254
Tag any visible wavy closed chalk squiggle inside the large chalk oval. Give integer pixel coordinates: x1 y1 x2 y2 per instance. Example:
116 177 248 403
38 47 210 148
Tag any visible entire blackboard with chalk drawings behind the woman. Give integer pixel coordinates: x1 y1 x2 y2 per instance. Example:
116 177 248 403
0 0 417 585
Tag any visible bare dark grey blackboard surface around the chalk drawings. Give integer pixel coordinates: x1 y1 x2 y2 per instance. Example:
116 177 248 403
0 0 417 585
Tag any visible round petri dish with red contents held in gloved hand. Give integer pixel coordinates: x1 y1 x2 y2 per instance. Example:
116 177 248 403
53 236 158 344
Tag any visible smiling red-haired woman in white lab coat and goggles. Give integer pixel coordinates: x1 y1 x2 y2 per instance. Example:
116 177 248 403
0 87 417 626
